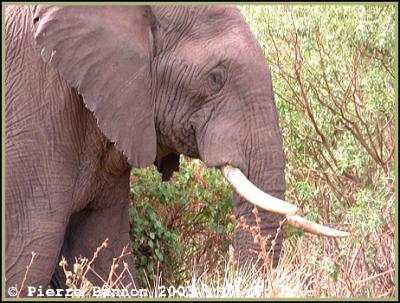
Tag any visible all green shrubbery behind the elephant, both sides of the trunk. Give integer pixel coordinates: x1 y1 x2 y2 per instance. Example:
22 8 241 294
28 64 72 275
126 4 398 298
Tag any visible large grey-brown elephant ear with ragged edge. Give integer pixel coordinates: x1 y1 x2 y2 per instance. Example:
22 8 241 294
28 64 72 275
33 6 156 167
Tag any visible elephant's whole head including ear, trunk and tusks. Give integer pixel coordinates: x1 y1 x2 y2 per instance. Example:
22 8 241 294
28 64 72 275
33 6 343 270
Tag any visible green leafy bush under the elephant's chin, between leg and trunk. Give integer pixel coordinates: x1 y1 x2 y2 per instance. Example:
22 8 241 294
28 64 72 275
130 156 233 285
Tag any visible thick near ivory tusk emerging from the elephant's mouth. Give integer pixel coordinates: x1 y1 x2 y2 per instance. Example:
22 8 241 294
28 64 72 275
221 165 297 215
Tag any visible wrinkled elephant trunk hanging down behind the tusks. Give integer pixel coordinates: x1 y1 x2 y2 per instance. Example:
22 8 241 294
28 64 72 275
233 134 286 266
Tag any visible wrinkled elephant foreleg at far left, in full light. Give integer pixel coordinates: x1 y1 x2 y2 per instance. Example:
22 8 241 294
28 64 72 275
6 205 68 297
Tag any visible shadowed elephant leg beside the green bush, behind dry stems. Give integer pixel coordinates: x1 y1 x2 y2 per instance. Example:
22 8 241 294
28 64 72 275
52 203 138 289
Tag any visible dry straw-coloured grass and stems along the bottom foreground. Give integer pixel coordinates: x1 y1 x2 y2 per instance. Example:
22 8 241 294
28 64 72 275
14 212 396 298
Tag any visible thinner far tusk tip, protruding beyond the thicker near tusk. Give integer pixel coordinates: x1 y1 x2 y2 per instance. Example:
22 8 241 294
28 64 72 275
286 216 350 238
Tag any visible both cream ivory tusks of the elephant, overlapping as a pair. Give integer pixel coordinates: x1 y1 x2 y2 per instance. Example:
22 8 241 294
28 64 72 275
220 165 350 238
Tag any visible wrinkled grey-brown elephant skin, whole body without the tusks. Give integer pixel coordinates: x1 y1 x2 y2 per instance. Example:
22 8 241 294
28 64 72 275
5 6 285 294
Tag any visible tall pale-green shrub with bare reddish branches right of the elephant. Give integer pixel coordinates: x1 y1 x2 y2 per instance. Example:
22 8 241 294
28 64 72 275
242 5 396 297
